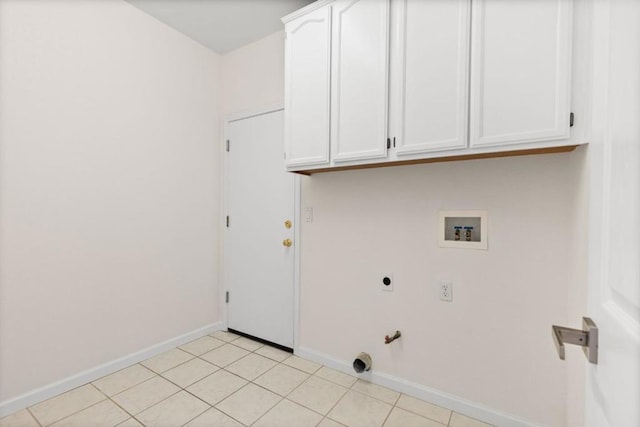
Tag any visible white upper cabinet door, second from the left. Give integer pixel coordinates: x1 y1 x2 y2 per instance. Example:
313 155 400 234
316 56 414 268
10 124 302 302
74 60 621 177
331 0 389 162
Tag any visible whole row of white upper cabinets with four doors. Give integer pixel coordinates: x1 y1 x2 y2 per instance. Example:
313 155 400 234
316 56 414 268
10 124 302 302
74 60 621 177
283 0 590 173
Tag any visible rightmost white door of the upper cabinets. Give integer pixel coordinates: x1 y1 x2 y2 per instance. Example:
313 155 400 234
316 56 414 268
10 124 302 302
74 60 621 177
470 0 572 146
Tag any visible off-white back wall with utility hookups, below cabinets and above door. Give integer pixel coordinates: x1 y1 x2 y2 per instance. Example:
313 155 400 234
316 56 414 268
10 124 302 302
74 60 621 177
223 33 586 426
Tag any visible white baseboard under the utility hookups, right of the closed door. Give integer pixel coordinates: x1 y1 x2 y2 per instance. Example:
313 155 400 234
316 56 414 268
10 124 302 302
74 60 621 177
295 347 539 427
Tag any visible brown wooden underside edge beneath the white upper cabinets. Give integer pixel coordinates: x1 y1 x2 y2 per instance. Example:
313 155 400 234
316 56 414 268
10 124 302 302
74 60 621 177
291 145 578 175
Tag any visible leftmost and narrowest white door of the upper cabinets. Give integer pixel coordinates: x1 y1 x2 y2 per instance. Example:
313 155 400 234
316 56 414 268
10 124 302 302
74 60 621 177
285 6 331 170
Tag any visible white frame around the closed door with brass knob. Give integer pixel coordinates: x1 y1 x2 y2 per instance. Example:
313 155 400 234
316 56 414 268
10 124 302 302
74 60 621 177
219 104 301 353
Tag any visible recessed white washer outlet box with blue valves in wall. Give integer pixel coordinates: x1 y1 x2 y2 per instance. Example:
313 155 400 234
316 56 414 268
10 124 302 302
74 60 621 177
438 210 488 250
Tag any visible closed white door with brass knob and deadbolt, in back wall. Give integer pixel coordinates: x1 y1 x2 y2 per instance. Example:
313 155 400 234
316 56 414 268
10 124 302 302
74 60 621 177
225 110 296 348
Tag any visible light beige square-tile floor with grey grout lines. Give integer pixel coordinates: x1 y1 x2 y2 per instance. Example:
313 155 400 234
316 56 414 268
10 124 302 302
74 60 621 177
0 331 496 427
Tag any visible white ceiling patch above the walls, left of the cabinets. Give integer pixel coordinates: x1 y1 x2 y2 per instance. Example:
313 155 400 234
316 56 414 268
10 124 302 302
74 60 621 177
126 0 314 54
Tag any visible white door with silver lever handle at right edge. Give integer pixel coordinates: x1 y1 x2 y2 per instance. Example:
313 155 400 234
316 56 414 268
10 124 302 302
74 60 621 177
585 0 640 427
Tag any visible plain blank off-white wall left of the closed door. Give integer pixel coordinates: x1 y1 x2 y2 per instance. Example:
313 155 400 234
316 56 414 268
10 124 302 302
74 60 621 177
0 0 220 403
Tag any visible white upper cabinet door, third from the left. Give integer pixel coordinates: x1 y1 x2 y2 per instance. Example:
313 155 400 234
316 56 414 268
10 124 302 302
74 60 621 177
390 0 471 155
